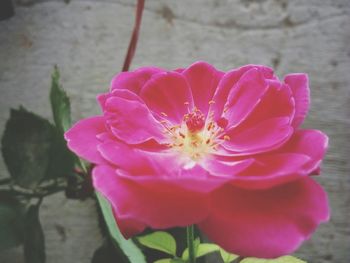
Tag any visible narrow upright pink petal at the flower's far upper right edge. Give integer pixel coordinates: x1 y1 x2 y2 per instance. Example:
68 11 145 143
284 73 310 128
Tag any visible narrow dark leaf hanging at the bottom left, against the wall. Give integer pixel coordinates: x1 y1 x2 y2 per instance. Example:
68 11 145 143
24 205 46 263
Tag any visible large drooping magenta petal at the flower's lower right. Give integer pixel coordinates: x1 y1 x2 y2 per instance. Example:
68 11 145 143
199 177 329 258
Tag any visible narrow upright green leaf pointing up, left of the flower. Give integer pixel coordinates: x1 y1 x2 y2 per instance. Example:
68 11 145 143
50 66 72 134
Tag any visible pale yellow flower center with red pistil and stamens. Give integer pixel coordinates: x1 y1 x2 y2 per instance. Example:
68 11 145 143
163 104 229 163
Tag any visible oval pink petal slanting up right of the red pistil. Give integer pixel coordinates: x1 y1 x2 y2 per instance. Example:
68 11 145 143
223 68 268 128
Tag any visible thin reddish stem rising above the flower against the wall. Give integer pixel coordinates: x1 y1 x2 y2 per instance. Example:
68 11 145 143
122 0 145 71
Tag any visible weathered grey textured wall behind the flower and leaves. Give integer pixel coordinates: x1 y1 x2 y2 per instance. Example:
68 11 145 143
0 0 350 263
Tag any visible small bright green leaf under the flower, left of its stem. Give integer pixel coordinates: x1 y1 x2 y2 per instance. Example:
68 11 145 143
137 231 176 256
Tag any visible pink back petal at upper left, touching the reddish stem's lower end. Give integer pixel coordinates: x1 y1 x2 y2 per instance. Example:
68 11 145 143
111 67 164 94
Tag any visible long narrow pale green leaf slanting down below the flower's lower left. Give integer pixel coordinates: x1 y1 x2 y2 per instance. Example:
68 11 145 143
96 192 146 263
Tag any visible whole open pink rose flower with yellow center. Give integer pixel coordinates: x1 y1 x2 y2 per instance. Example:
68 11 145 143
65 62 329 258
